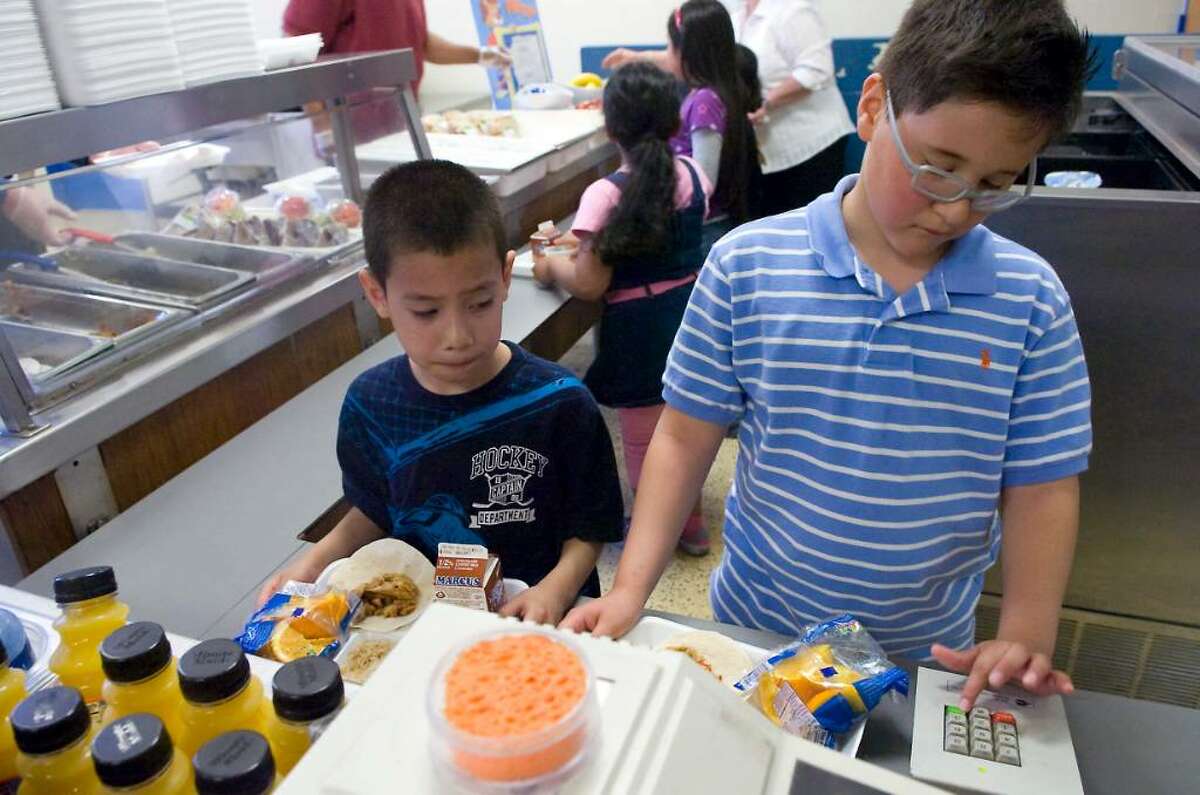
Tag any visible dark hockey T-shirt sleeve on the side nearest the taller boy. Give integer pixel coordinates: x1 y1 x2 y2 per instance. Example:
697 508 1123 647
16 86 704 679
558 387 625 544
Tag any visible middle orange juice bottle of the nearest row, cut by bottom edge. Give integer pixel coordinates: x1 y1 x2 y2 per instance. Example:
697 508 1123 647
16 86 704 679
91 712 194 795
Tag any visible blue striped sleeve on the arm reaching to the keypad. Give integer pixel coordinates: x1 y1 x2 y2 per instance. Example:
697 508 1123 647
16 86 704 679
1003 301 1092 486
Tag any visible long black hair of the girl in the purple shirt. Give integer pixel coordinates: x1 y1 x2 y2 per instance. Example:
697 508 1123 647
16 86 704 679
667 0 762 222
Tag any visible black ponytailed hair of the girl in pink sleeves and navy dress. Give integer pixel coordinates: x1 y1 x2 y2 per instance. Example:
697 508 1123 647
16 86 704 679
596 61 679 268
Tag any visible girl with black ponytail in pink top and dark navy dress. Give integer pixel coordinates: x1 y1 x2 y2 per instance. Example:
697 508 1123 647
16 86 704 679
534 62 713 555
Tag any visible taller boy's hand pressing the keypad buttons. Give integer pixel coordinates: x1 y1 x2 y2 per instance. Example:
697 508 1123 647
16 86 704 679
930 640 1075 710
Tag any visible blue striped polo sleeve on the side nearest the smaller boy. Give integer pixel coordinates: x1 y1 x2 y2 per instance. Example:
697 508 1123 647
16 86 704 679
662 255 745 425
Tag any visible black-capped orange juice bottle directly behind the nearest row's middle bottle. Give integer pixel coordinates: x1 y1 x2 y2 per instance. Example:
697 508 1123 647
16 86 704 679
100 621 184 737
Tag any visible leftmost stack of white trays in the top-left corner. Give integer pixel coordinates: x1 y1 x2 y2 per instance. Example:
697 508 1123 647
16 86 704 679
0 0 60 119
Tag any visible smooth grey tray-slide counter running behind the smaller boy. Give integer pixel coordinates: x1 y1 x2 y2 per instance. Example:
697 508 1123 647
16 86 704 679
18 279 568 638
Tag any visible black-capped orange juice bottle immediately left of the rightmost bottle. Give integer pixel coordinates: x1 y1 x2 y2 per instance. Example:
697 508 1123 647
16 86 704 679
179 639 270 757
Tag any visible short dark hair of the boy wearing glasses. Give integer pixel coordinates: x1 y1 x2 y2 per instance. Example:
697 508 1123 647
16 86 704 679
878 0 1098 142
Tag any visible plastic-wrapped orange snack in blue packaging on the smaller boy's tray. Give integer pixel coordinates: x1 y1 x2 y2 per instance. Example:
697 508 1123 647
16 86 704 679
236 582 361 663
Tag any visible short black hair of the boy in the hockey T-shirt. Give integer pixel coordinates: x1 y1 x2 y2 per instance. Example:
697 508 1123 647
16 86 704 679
362 160 508 286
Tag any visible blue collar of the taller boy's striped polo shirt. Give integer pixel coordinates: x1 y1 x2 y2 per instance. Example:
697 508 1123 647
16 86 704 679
808 174 996 295
